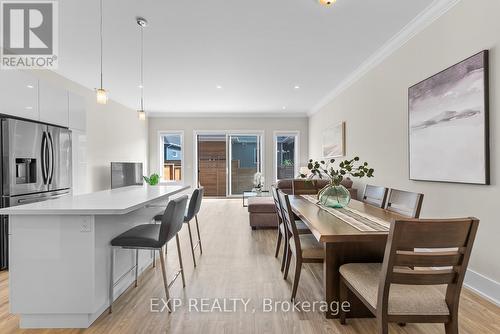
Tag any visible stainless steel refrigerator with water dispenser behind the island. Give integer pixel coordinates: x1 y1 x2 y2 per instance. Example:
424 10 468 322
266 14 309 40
0 118 71 270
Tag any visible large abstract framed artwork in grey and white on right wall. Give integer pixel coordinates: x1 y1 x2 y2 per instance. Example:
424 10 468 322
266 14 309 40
408 50 490 184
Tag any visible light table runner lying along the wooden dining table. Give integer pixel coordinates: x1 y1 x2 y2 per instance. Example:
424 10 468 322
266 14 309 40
302 195 391 232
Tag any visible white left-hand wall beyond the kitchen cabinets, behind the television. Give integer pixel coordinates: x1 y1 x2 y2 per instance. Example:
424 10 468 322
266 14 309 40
30 70 148 191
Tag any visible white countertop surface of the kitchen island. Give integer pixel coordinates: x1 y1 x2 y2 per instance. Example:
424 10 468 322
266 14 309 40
0 184 189 215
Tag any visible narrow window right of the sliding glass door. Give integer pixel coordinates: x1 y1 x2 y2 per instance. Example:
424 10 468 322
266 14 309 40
274 132 299 180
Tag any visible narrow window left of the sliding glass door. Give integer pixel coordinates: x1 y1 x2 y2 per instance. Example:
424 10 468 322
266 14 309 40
160 132 183 182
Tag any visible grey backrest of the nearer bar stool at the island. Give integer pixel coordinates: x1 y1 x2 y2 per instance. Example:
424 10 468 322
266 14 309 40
158 195 188 244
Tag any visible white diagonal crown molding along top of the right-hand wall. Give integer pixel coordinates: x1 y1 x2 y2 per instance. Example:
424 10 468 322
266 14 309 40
307 0 461 116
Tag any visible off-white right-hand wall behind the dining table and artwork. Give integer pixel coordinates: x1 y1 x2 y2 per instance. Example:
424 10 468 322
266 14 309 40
309 0 500 301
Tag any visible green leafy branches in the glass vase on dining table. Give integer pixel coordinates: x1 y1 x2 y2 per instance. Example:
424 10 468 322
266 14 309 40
300 157 375 186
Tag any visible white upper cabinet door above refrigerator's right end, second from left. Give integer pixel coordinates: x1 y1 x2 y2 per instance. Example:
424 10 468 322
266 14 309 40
38 80 69 127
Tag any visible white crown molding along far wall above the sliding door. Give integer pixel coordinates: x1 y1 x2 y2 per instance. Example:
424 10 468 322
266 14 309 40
147 111 307 118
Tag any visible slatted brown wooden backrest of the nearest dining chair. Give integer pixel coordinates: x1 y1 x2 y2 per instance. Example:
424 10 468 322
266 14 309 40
377 218 479 314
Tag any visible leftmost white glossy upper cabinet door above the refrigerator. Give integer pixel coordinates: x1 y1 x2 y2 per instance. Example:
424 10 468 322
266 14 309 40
0 70 38 121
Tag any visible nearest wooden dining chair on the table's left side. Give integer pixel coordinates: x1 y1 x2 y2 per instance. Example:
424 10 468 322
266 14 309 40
278 190 325 301
